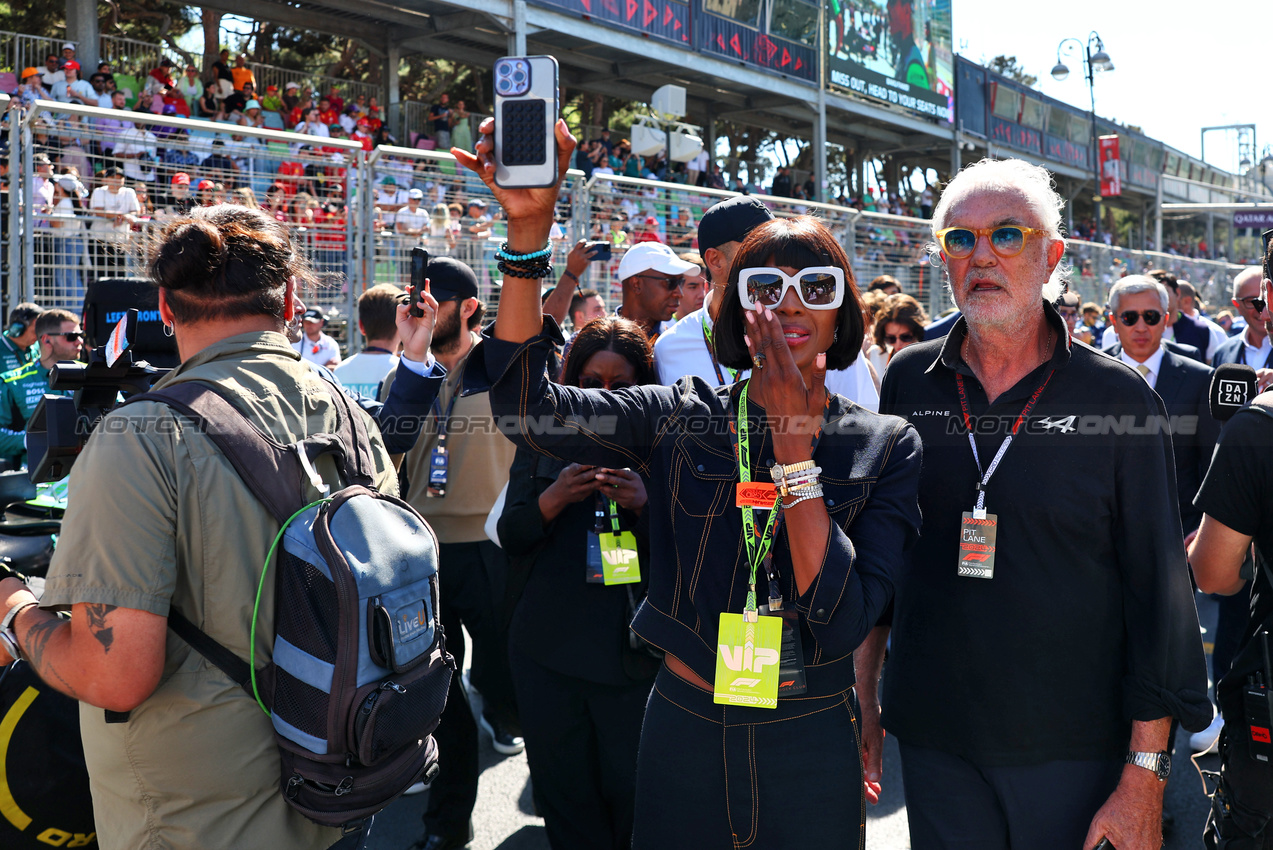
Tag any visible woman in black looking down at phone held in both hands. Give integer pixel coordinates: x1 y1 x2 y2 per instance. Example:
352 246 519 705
499 317 658 850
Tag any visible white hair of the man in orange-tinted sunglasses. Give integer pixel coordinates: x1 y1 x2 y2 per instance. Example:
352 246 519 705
927 159 1072 302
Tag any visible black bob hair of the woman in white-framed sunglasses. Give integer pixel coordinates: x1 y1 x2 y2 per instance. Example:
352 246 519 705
712 215 866 372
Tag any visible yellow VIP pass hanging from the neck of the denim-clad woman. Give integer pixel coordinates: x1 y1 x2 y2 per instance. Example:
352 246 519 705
712 612 783 709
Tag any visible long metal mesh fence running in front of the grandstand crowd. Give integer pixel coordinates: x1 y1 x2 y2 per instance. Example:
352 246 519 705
7 95 1240 358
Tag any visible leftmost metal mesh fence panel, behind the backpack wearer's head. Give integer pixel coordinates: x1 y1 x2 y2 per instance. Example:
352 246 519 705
6 96 365 325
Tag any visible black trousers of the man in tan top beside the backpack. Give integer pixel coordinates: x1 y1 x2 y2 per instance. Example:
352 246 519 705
424 541 517 837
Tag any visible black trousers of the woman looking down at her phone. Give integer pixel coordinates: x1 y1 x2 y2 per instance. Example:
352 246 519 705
512 648 653 850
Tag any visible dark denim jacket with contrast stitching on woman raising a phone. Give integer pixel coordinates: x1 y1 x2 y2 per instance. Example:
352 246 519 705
465 318 920 699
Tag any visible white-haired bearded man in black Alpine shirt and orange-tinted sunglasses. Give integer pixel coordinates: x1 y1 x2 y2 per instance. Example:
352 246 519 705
857 159 1212 850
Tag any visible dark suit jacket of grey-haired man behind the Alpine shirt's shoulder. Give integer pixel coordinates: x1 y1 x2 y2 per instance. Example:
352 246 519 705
1106 344 1221 526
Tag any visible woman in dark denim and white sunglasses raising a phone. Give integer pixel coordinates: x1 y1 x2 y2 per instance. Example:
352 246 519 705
452 121 920 850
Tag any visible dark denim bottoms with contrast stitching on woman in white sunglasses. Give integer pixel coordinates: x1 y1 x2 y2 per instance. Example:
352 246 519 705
633 667 866 850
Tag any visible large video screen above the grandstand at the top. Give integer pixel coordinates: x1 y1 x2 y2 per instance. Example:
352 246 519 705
826 0 955 121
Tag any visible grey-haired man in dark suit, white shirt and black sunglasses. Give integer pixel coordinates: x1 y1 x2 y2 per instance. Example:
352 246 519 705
1109 275 1220 534
